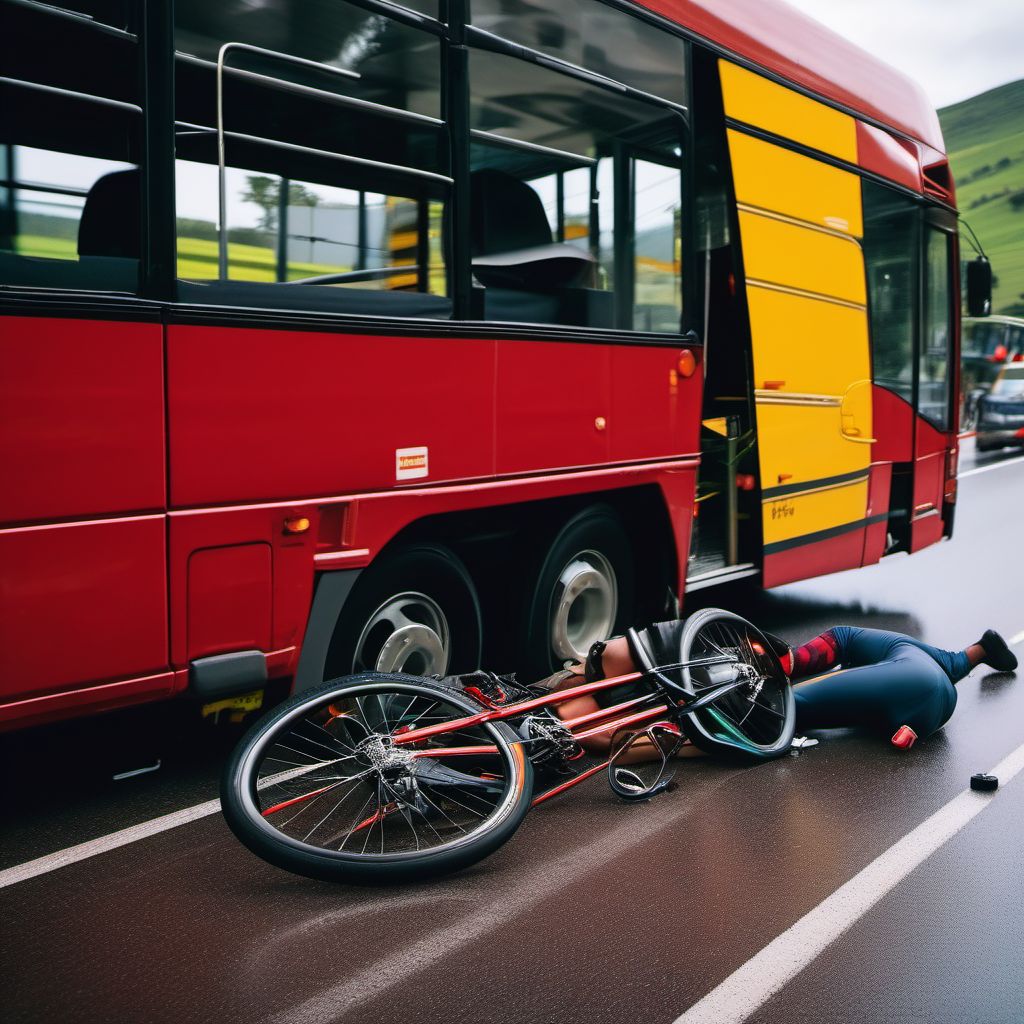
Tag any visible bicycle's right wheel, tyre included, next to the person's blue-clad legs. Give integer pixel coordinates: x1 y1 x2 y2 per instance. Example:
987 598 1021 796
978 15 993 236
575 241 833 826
680 608 797 760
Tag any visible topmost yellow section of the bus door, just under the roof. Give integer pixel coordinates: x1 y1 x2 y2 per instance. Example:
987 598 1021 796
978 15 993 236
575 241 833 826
719 60 857 164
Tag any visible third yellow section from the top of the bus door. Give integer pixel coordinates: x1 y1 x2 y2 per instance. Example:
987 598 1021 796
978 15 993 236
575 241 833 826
739 210 867 303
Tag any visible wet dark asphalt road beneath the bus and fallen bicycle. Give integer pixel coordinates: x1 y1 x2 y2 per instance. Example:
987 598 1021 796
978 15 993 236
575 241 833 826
0 442 1024 1024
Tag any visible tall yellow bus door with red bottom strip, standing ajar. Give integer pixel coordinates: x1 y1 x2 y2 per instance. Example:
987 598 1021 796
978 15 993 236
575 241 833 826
719 61 873 587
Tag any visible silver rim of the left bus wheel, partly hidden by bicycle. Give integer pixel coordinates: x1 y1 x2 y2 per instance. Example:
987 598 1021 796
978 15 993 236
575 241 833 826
352 591 452 676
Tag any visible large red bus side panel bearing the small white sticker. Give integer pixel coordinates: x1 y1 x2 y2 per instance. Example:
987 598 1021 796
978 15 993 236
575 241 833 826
167 326 495 508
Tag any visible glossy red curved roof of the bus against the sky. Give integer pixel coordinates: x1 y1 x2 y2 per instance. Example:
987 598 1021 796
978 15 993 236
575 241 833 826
637 0 945 153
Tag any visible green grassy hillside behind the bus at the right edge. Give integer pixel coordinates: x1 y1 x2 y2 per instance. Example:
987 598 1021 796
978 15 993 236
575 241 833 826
939 79 1024 316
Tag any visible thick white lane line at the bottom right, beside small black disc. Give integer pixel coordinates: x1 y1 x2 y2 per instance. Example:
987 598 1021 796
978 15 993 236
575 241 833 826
674 743 1024 1024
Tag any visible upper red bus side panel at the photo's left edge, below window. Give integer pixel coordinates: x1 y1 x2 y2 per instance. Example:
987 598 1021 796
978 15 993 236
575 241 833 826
0 316 165 523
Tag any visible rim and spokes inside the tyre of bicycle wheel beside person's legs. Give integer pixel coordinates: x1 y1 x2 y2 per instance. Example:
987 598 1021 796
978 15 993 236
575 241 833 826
684 620 792 753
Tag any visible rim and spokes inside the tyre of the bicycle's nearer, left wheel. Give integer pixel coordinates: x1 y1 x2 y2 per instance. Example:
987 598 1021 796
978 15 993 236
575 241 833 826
242 684 524 862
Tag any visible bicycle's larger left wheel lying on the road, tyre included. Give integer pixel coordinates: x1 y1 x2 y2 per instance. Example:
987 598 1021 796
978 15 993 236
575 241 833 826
221 673 532 883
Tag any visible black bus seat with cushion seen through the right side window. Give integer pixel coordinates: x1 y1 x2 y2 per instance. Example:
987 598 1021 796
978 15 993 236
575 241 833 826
470 169 595 291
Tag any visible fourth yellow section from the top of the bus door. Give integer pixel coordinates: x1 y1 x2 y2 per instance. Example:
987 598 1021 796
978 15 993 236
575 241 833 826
746 285 871 396
